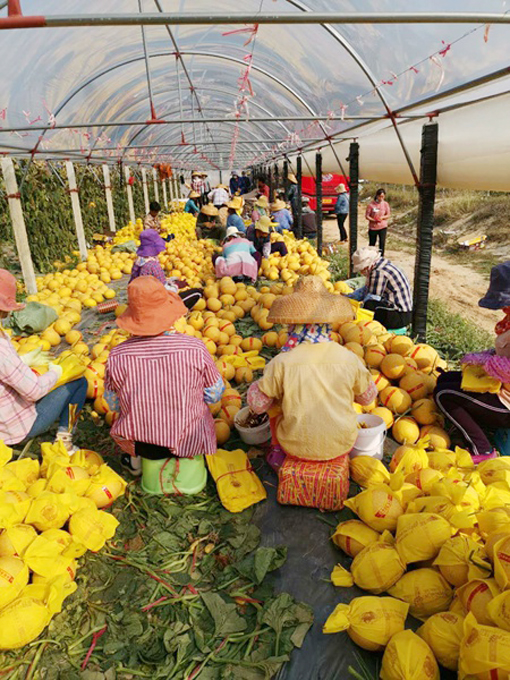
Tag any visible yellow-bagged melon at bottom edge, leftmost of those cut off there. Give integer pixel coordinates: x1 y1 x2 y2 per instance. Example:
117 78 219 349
380 630 439 680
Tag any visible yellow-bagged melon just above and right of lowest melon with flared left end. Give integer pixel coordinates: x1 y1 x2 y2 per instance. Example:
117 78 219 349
388 568 453 620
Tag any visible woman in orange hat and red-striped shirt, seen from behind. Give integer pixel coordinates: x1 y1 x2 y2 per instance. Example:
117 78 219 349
105 276 224 474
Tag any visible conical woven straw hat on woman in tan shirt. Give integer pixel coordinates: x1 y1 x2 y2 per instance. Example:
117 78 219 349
267 276 354 324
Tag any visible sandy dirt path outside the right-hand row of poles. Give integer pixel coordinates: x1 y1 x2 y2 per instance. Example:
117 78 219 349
323 219 501 332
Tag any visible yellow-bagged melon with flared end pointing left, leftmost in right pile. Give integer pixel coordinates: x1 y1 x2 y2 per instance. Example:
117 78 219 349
322 595 409 652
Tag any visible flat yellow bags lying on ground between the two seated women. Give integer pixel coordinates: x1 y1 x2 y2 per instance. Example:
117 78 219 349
205 449 267 512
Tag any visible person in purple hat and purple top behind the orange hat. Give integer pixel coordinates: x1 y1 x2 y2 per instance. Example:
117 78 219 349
129 229 202 309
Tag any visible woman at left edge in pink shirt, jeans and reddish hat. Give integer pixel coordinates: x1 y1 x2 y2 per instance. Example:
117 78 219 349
0 269 87 453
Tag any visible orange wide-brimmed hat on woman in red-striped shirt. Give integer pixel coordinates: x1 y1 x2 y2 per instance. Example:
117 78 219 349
117 276 188 336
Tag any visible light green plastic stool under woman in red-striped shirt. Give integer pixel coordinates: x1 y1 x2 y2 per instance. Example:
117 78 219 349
142 456 207 496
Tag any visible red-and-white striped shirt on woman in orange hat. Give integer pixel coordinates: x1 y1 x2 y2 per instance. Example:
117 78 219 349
105 333 220 458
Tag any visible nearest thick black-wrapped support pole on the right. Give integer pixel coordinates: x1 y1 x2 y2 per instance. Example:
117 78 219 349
413 123 439 342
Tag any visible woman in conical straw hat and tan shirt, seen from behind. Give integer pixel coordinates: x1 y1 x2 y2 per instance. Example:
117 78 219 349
248 276 377 461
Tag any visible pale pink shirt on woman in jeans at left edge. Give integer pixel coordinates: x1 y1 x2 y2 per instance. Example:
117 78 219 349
0 334 58 445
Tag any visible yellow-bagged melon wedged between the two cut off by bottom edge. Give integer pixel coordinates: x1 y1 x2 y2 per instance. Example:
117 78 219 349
416 612 464 671
